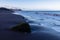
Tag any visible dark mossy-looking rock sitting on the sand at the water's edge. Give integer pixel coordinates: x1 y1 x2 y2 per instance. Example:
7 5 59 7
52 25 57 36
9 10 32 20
12 23 31 33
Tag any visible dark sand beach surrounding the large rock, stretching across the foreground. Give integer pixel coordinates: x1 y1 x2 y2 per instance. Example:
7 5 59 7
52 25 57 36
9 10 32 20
0 7 60 40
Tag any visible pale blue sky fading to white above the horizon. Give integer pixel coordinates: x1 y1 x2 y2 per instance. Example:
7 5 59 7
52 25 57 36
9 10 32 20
0 0 60 10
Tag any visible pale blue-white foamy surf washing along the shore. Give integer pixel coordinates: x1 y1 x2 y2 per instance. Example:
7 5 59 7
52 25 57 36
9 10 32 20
14 11 60 32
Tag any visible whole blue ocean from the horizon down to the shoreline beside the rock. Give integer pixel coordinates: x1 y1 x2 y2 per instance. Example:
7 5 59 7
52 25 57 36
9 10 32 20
14 11 60 32
